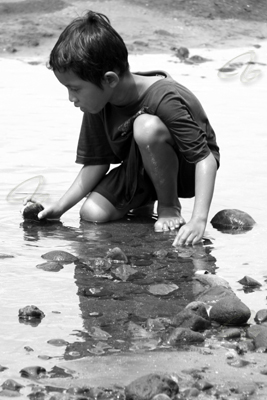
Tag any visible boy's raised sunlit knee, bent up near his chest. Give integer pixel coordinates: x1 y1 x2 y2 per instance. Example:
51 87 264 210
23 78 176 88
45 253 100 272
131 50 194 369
133 114 171 146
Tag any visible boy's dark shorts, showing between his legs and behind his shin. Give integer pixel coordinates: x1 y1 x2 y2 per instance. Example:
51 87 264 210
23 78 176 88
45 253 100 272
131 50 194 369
93 152 195 209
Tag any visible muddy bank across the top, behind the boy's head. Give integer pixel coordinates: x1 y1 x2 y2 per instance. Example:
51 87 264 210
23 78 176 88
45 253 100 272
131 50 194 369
0 0 267 60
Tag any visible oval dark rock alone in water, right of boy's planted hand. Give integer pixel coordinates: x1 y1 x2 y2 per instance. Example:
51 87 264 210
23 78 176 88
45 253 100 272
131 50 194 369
210 209 256 233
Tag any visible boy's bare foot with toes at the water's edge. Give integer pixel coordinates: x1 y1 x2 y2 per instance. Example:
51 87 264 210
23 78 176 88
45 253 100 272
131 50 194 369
154 206 185 232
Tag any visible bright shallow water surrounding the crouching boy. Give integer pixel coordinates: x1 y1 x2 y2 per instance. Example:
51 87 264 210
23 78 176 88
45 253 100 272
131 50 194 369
0 44 267 388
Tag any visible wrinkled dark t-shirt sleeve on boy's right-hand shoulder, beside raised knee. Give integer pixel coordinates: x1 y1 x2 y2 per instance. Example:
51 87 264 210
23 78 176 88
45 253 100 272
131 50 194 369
156 92 213 163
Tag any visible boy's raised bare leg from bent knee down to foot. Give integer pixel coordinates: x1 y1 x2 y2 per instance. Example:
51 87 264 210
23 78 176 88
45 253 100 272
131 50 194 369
134 114 185 232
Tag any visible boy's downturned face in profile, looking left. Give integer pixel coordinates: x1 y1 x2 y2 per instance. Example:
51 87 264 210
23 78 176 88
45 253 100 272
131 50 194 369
54 71 112 114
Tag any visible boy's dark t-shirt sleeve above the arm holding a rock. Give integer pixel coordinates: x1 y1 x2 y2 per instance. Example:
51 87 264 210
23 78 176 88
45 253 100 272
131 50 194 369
76 113 120 165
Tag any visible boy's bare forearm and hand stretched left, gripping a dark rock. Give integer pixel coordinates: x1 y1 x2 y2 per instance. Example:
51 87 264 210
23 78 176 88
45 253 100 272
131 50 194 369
38 165 109 219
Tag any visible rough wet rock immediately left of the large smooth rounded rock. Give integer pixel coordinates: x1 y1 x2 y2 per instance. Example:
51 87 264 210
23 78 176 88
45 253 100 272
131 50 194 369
172 309 210 332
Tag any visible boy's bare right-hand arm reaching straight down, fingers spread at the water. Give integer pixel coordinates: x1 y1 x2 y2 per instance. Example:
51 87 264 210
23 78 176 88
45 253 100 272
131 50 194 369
173 153 217 246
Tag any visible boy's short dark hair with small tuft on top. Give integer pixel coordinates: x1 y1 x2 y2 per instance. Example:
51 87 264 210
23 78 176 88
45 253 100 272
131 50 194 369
48 11 129 88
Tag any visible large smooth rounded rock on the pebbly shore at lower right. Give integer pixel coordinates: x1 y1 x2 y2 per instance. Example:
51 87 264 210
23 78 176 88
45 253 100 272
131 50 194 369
210 297 251 325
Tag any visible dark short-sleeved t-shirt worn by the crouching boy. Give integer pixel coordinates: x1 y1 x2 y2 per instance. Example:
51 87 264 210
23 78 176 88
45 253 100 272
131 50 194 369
76 71 220 205
